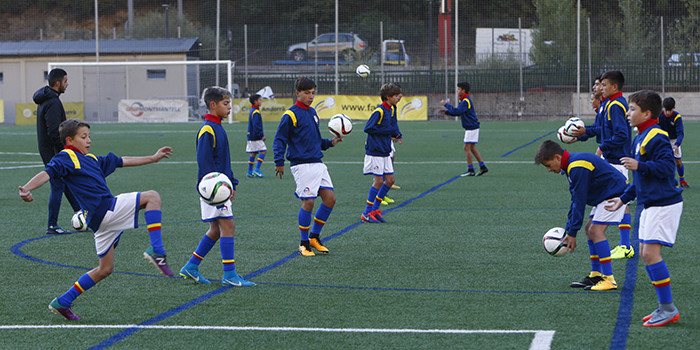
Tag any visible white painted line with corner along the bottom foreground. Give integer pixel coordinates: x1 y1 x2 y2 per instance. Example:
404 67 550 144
0 324 556 350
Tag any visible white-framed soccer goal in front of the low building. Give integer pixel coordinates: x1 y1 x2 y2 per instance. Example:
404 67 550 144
47 60 238 123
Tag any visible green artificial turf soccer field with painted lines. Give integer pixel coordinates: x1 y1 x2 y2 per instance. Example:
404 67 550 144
0 120 700 350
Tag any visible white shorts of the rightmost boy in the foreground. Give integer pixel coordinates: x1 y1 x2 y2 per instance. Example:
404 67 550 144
639 202 683 247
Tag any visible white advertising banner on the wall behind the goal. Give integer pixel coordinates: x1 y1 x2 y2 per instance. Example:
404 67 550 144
119 100 189 123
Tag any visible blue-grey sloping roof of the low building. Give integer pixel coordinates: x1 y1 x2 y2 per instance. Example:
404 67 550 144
0 38 198 56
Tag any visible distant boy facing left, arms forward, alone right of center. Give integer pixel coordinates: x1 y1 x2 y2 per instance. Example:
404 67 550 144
440 81 489 176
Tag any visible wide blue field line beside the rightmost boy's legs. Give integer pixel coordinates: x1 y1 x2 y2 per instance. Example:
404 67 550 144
610 207 642 350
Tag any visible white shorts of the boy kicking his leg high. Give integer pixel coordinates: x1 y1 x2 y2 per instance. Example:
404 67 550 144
95 192 141 258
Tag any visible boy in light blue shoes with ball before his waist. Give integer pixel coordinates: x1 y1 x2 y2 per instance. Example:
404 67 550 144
180 86 255 287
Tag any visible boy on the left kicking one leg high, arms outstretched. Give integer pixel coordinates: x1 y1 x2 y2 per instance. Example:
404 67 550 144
19 119 173 320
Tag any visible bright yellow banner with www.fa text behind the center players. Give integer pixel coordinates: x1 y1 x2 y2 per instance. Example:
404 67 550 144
311 95 428 120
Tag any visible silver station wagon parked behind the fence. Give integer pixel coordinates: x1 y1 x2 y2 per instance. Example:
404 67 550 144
287 33 367 62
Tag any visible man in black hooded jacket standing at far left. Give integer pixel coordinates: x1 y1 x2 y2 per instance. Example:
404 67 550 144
34 68 80 235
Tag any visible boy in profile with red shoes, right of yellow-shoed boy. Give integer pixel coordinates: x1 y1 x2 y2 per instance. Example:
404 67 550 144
361 83 403 223
